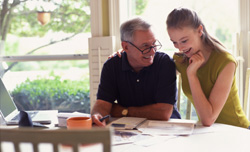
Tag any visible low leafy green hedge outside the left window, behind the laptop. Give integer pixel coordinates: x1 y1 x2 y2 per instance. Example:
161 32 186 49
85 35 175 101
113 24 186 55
11 74 90 113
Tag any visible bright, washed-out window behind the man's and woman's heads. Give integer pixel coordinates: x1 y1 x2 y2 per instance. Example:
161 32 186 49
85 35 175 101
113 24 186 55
123 0 238 119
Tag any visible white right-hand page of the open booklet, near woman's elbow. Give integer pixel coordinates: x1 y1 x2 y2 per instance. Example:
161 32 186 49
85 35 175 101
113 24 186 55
142 119 196 135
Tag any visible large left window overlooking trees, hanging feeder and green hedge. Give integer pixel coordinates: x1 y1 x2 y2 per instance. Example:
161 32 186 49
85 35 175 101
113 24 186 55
0 0 91 113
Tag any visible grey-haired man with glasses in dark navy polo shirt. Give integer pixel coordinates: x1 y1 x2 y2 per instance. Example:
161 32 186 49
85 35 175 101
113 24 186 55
91 18 180 126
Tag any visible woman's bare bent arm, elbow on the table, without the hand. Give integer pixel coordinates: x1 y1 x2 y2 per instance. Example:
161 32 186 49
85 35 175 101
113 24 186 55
188 62 236 126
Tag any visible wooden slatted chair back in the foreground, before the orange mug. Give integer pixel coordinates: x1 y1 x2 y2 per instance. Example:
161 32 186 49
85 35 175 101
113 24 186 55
0 128 111 152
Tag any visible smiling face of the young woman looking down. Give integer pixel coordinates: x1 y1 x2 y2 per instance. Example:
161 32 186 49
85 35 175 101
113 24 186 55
168 26 202 58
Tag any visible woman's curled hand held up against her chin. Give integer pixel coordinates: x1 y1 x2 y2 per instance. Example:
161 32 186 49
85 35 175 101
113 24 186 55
187 51 205 76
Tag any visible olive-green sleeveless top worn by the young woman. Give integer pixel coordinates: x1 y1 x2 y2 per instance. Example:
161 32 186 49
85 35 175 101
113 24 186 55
173 51 250 128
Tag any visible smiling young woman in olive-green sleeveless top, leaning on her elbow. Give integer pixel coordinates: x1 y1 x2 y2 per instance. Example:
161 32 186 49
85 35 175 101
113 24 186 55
166 8 250 128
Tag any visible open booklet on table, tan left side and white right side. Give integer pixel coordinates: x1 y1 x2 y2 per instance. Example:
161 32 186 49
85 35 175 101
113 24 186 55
108 117 196 135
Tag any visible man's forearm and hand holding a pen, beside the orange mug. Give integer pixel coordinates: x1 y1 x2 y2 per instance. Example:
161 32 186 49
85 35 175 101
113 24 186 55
91 100 112 126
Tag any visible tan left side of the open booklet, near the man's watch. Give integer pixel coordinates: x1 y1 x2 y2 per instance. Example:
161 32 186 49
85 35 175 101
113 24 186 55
110 117 146 130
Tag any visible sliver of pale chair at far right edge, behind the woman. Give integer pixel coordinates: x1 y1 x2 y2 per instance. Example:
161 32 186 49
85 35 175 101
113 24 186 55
243 68 250 120
